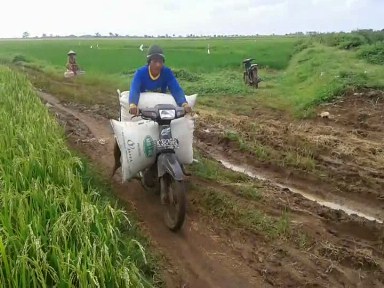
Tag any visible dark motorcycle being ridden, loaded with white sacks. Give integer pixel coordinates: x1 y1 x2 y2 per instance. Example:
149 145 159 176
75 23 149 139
139 104 187 231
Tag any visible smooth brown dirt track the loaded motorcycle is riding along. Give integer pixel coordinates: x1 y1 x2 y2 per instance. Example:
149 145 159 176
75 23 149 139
39 92 270 288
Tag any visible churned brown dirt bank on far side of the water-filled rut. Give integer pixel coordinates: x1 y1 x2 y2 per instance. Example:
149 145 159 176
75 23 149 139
196 91 384 220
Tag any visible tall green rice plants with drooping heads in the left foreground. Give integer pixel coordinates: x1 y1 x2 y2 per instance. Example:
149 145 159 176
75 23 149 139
0 68 153 287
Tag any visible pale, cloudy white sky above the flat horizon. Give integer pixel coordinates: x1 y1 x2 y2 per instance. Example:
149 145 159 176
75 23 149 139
0 0 384 38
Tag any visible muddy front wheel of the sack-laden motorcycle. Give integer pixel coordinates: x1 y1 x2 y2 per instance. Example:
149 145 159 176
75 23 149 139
160 174 186 231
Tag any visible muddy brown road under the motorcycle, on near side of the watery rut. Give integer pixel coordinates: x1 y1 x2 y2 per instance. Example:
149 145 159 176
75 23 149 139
40 93 384 288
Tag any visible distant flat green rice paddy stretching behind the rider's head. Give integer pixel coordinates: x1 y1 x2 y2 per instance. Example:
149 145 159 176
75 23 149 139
0 37 297 75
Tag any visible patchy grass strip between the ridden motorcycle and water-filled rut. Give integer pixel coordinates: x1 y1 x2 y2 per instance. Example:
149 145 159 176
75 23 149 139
191 152 291 239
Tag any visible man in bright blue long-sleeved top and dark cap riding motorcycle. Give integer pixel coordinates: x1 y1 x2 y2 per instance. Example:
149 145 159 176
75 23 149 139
129 45 192 115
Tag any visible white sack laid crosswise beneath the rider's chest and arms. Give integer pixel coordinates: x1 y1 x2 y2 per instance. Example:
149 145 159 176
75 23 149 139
119 91 197 121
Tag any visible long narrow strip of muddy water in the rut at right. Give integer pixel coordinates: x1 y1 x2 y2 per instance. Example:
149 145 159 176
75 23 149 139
214 159 383 224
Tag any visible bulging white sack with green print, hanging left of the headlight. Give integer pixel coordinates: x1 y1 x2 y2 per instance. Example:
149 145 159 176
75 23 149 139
110 119 159 182
